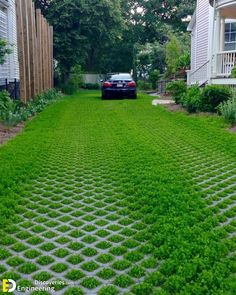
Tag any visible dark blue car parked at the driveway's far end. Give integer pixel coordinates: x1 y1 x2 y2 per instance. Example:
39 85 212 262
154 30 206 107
101 74 137 99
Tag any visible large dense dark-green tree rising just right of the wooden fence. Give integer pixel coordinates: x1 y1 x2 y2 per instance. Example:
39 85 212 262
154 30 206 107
47 0 123 78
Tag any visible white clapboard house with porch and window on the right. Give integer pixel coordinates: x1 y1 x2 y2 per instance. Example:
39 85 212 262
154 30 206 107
188 0 236 85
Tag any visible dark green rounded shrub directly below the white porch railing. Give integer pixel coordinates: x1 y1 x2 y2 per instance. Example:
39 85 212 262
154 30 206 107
200 85 232 112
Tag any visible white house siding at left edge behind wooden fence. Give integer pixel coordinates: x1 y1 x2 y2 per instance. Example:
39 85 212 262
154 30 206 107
0 0 19 85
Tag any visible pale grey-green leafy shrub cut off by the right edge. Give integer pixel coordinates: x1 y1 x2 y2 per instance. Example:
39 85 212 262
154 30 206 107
218 96 236 125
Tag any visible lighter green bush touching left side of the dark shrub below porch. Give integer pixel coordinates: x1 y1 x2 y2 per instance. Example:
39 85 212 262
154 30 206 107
181 85 202 113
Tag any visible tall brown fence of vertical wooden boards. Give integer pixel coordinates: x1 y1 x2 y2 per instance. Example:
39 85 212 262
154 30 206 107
16 0 53 102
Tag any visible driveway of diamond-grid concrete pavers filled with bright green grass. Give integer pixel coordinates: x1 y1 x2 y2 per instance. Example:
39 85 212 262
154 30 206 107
0 91 236 295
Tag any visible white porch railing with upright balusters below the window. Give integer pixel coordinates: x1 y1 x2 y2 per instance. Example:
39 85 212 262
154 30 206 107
216 50 236 78
